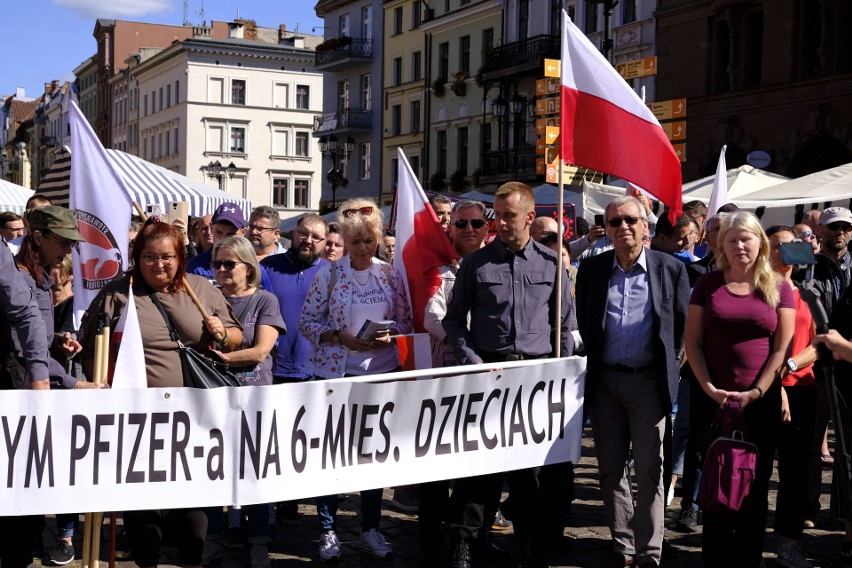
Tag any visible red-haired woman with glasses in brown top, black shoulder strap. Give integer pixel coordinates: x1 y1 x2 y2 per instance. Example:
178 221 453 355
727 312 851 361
81 217 243 568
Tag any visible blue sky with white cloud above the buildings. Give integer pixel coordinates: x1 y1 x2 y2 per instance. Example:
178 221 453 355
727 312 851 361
0 0 323 97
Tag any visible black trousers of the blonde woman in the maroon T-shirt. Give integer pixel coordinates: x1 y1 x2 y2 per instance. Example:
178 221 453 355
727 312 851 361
701 388 781 568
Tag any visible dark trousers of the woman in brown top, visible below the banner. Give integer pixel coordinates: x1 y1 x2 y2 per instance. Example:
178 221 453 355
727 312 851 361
124 509 207 568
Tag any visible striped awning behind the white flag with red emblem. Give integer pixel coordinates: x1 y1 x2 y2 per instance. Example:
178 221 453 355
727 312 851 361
39 150 251 217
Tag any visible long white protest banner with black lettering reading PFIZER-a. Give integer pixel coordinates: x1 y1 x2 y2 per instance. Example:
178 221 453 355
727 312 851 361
0 357 586 515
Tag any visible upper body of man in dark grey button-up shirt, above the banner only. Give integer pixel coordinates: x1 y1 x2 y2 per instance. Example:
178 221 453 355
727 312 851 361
443 182 574 365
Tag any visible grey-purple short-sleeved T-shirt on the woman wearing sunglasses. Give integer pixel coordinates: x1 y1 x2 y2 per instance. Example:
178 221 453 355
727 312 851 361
225 290 287 386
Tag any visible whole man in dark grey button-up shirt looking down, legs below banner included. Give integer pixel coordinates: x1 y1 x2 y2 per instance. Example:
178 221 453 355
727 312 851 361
442 182 574 568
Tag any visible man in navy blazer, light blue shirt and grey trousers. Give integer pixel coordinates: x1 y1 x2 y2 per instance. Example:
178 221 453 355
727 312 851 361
575 197 690 568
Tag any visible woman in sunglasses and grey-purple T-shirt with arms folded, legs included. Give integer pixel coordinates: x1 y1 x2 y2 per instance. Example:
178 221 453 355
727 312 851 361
207 236 287 568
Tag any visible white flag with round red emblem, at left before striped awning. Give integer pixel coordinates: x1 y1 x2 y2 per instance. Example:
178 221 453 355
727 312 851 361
69 101 131 325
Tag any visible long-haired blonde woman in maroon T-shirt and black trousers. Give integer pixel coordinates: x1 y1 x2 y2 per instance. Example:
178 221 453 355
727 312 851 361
685 212 796 568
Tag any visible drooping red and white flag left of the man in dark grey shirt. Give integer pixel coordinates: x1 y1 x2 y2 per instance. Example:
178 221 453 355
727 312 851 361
393 148 459 332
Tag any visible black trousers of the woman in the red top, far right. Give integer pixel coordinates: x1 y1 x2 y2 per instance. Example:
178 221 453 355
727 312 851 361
775 386 816 538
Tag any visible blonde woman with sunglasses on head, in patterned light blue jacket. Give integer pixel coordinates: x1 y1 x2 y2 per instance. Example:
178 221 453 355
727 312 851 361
299 198 412 560
